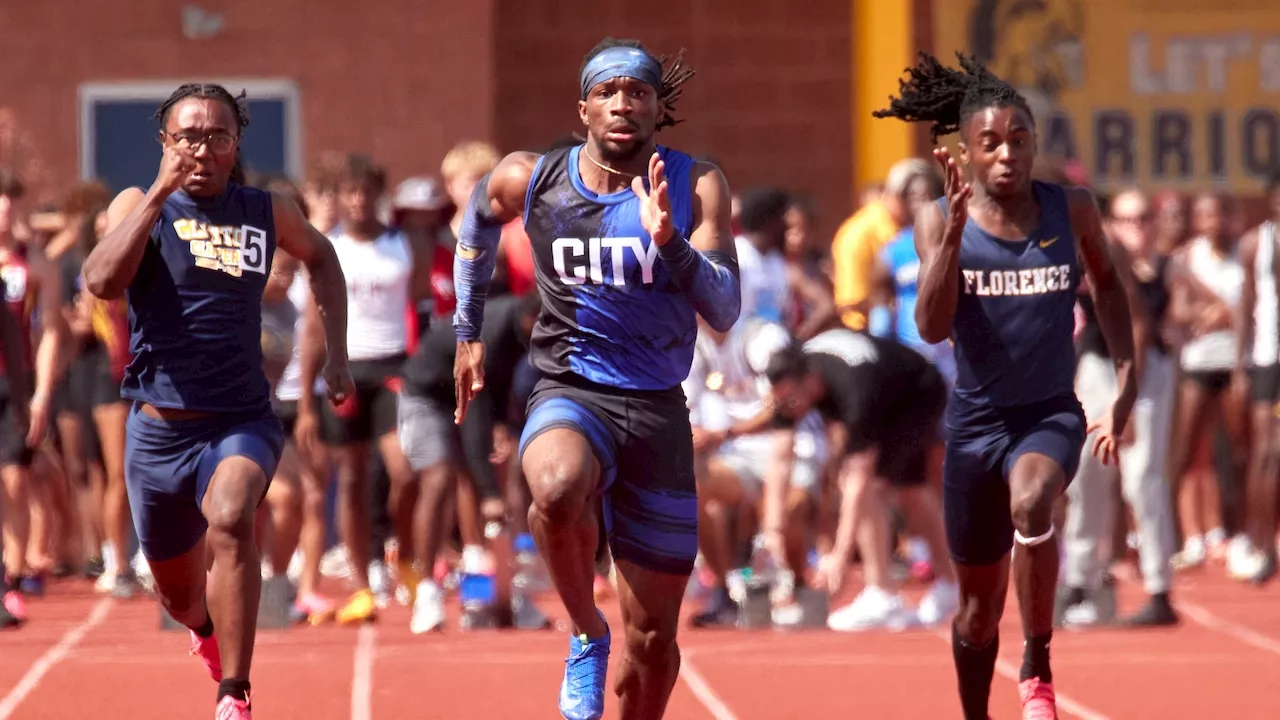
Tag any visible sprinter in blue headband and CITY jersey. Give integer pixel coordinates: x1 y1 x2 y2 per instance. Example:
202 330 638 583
454 38 741 720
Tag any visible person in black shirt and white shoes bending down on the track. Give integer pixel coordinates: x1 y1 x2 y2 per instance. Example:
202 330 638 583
765 328 955 630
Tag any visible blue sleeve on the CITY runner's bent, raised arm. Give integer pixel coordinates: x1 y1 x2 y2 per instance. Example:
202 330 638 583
658 234 742 332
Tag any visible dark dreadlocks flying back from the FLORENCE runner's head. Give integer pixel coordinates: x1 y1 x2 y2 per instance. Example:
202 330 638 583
872 53 1032 142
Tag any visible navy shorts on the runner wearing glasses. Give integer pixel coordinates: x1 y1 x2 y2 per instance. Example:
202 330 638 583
124 402 284 561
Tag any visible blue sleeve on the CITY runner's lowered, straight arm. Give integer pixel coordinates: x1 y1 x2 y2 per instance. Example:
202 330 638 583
453 176 502 342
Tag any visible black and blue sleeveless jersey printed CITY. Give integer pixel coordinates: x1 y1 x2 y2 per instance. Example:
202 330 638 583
525 147 698 389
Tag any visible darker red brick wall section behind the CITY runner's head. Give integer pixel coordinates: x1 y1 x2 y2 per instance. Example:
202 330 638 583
494 0 852 233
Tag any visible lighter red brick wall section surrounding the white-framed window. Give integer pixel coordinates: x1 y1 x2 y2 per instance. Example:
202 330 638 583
0 0 493 202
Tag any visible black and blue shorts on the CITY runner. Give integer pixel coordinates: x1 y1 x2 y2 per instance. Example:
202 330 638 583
520 377 698 575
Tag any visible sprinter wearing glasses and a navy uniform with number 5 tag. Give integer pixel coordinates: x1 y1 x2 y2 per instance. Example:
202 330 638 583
83 85 351 720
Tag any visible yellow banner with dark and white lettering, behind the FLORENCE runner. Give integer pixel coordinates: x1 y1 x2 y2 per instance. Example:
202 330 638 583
933 0 1280 195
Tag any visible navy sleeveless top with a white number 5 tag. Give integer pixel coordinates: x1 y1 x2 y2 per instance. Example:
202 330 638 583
120 184 275 413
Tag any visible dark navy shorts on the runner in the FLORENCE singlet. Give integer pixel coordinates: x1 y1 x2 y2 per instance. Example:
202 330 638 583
942 393 1085 565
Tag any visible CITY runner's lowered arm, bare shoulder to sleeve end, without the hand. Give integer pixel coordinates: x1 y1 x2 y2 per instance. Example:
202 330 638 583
453 152 538 342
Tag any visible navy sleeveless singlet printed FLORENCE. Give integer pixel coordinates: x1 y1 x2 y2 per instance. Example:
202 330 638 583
941 182 1080 407
